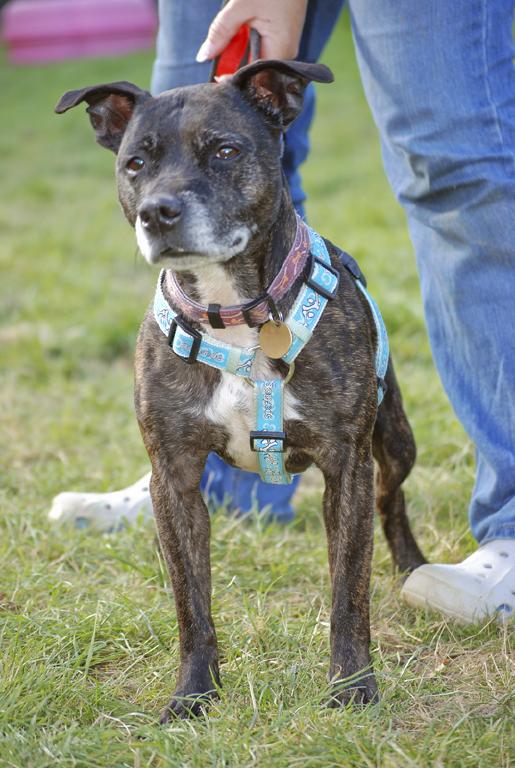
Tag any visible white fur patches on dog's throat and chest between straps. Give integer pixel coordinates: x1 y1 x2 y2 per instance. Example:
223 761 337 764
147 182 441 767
197 265 300 472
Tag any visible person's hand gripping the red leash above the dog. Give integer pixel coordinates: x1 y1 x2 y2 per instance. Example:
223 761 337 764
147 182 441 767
197 0 308 62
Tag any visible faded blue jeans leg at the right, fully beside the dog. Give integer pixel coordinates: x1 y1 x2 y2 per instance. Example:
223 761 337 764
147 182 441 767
349 0 515 543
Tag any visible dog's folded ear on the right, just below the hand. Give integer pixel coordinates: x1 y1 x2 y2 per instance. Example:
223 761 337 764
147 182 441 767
231 59 334 129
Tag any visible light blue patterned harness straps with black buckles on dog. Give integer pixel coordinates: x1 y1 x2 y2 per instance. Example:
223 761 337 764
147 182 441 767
154 228 390 484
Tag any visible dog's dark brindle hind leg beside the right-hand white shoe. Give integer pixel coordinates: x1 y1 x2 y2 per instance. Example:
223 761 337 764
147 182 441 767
373 360 426 572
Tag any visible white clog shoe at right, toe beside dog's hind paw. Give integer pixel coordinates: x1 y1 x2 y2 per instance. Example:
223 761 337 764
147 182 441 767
401 539 515 624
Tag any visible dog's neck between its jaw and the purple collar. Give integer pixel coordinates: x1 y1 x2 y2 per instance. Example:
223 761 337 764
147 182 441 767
165 188 297 318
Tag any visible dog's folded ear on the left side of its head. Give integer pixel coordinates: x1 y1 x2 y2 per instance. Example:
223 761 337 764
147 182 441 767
55 81 152 152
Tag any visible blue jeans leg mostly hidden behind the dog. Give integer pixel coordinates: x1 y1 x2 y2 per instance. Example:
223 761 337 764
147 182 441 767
151 0 343 522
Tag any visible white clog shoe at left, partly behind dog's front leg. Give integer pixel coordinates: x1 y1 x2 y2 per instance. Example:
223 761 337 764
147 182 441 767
48 472 152 532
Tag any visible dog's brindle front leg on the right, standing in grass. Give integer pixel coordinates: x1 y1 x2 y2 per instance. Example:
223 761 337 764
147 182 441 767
323 437 378 707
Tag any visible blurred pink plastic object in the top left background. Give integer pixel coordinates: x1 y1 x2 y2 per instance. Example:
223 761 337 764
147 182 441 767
2 0 157 64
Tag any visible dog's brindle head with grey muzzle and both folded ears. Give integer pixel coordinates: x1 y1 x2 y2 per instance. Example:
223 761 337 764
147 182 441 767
56 60 333 270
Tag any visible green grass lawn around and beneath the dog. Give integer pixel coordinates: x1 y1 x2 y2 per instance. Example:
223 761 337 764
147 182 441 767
0 13 515 768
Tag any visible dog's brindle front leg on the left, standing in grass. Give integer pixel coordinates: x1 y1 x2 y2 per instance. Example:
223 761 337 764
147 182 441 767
150 454 220 723
